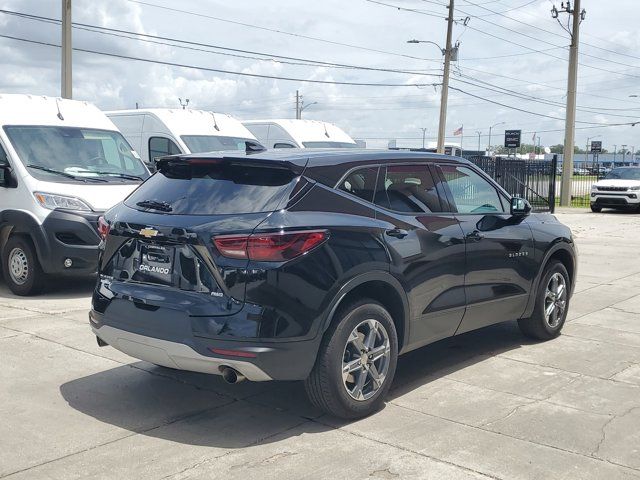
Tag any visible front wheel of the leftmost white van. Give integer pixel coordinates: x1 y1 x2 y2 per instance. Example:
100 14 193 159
2 235 44 296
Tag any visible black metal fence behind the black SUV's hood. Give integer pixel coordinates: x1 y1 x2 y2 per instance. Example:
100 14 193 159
467 155 559 212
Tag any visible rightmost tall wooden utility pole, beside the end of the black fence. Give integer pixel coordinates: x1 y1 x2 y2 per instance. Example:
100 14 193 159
551 0 586 207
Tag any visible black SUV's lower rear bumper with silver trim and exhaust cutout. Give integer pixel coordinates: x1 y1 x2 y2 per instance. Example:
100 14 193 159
89 310 319 382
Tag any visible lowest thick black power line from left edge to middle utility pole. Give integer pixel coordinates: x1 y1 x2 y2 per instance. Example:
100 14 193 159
0 34 438 87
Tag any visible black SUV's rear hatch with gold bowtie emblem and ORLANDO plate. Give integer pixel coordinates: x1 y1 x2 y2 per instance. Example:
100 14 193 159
100 157 304 316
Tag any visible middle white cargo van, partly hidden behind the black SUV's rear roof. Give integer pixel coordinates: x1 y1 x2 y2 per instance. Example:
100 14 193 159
105 108 256 169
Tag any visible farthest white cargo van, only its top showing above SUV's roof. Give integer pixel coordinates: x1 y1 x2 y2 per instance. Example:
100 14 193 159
242 119 358 148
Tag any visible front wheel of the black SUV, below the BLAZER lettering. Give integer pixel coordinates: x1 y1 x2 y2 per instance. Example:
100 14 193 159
518 261 571 340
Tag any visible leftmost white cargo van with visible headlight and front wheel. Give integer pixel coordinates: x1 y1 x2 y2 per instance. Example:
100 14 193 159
0 94 149 295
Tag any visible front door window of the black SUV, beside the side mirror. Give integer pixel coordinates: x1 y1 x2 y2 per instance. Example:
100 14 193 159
440 165 504 213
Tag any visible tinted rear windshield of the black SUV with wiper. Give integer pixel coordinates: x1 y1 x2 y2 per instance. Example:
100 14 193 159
124 163 296 215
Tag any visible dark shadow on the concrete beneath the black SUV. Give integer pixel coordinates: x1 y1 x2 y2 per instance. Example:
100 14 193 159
60 322 529 448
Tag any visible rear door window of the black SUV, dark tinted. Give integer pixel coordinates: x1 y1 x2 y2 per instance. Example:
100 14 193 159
375 165 442 213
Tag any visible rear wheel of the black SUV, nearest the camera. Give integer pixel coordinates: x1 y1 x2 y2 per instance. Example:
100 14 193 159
305 299 398 419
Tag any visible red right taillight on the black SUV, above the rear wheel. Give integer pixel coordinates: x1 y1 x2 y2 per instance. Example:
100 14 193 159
213 230 329 262
